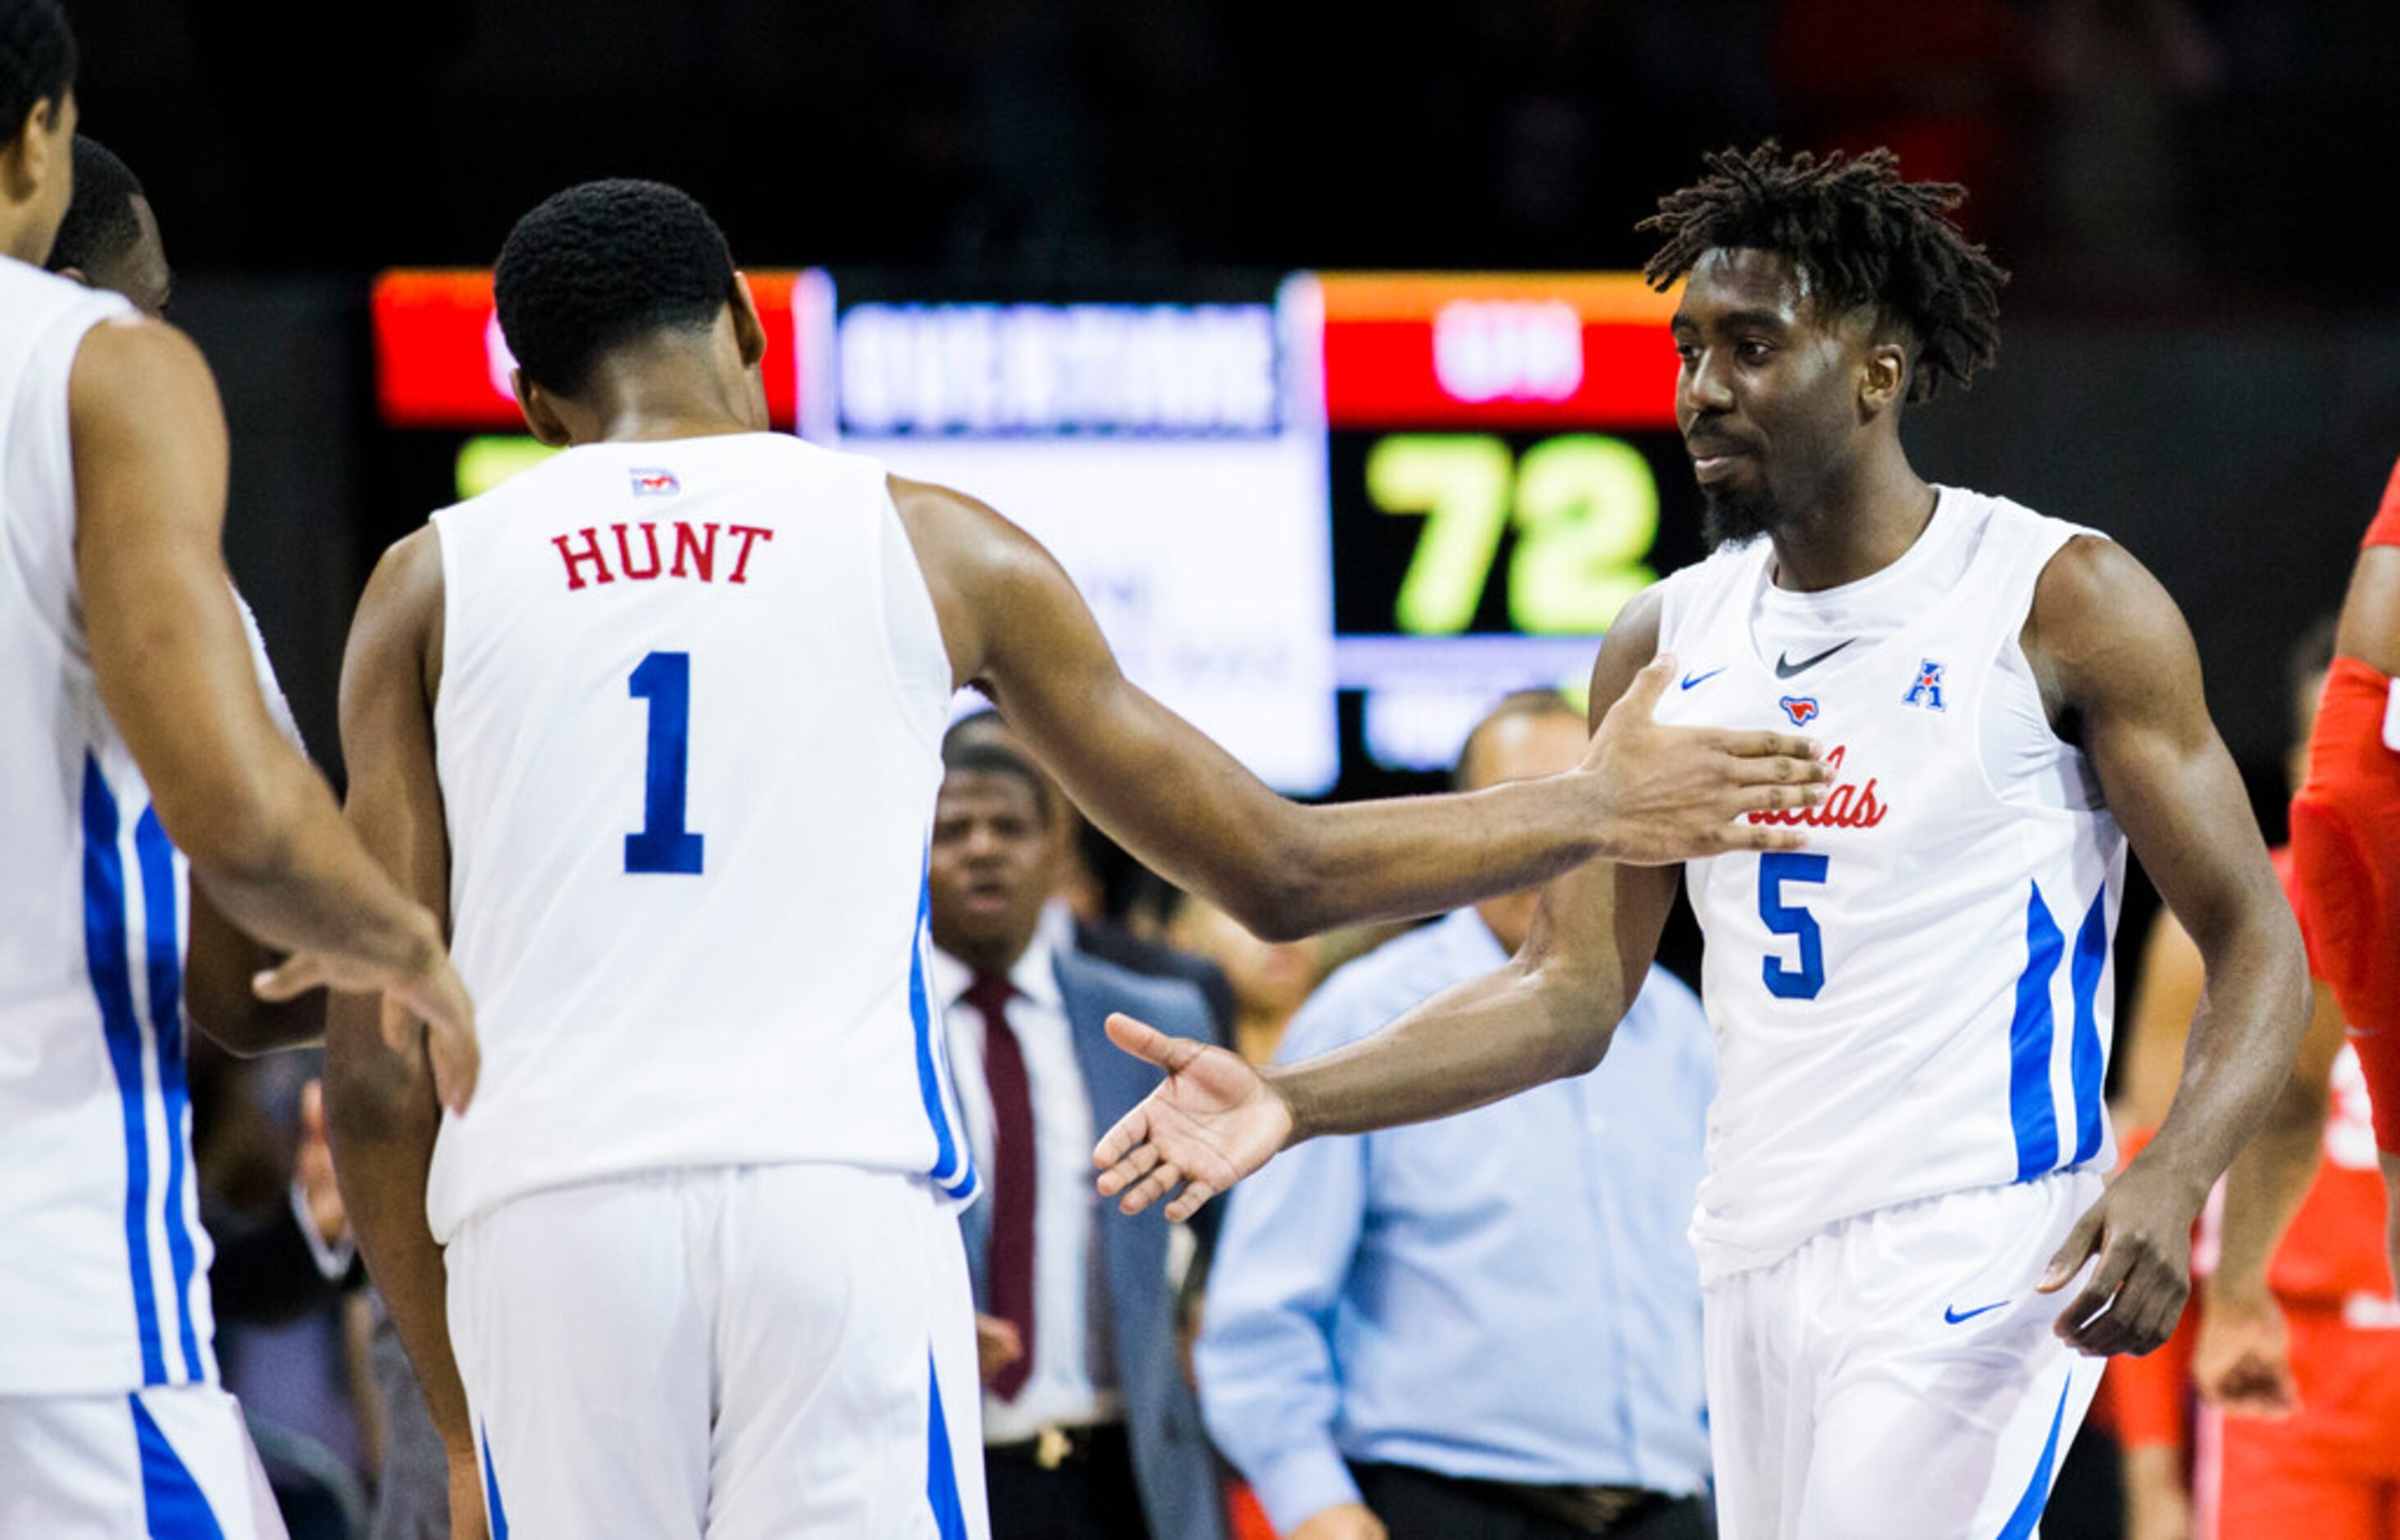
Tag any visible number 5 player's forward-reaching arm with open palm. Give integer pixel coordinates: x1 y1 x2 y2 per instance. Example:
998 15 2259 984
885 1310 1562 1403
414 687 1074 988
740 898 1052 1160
1095 597 1680 1219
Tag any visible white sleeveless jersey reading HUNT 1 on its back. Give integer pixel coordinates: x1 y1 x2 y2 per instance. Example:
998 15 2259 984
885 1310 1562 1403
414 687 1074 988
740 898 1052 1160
427 434 974 1240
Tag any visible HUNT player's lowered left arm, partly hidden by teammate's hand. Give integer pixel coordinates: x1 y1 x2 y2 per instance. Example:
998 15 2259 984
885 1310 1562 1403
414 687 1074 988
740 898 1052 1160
324 528 476 1463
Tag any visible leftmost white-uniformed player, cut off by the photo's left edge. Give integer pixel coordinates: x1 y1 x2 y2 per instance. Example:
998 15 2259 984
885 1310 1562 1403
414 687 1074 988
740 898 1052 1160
0 0 473 1540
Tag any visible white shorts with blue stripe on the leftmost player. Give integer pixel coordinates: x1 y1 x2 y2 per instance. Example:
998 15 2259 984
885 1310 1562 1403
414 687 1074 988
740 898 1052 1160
0 1384 283 1540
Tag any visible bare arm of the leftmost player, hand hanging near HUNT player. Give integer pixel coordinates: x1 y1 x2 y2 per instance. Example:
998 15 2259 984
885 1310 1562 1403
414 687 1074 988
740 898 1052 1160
70 321 476 1106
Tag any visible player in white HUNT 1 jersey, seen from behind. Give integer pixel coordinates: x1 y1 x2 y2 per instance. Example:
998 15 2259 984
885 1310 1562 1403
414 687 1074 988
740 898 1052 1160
326 182 1817 1538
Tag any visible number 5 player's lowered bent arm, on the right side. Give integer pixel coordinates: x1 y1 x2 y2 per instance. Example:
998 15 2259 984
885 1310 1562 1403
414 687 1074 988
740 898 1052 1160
2025 537 2309 1355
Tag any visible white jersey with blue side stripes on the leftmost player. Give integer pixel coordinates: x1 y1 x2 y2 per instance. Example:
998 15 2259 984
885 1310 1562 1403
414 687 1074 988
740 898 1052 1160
0 259 216 1396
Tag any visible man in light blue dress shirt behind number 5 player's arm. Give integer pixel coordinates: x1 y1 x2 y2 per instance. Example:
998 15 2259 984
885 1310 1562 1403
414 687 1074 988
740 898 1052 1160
1198 693 1716 1540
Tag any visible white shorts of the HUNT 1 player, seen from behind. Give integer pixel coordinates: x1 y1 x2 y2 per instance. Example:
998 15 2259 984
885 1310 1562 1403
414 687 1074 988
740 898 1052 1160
449 1166 989 1540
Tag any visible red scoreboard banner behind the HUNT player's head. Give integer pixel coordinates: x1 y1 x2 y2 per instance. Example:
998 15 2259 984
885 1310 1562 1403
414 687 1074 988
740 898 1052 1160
372 269 799 432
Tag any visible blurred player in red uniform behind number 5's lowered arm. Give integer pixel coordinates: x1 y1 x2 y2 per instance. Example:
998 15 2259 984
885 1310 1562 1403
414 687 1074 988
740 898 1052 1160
2112 626 2400 1540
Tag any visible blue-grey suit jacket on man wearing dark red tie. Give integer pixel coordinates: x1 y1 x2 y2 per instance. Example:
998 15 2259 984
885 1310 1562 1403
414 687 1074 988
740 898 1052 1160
963 952 1224 1540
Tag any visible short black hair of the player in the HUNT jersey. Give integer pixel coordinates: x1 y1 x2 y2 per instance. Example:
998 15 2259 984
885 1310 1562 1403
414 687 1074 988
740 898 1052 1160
492 177 735 396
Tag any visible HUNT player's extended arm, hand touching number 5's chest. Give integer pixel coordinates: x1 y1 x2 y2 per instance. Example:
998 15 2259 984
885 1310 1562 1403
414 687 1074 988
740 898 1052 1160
893 480 1824 938
